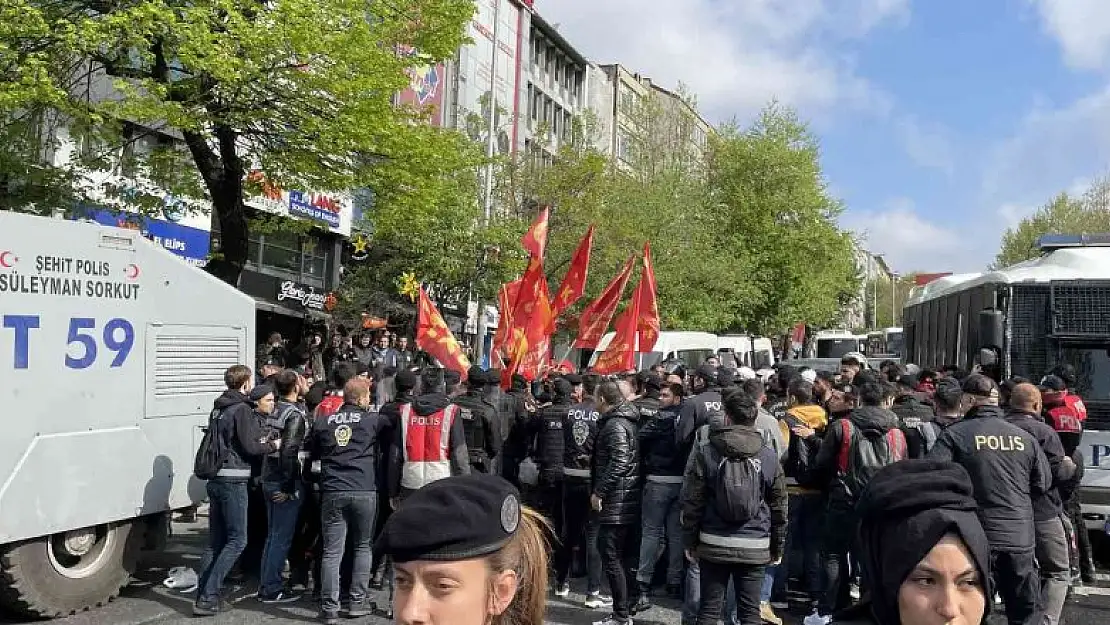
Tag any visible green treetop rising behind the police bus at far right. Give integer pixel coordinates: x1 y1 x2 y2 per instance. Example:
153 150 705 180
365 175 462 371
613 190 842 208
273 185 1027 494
991 178 1110 269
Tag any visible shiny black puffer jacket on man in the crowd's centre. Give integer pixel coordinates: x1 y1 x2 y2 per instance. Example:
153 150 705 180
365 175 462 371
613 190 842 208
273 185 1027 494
593 402 643 525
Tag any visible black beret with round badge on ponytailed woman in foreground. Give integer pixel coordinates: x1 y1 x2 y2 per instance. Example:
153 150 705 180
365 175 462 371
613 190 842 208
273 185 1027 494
374 473 521 562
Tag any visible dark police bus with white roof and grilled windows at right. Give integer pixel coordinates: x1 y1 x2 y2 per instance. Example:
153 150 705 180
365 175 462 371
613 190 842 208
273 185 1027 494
902 234 1110 530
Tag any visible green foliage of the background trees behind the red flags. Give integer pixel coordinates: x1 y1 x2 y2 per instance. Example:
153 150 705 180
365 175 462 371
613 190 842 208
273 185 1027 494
500 91 858 333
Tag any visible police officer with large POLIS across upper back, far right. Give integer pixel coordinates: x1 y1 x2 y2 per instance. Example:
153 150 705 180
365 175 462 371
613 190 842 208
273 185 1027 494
929 373 1051 625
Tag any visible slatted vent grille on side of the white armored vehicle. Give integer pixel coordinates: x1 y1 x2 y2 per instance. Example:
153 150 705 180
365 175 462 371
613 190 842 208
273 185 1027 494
154 334 241 397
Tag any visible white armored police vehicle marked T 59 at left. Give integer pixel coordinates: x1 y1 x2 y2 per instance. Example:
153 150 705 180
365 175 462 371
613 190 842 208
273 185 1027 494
0 211 254 617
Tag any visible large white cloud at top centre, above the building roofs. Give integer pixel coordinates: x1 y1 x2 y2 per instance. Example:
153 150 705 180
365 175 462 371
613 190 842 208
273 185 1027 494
536 0 909 121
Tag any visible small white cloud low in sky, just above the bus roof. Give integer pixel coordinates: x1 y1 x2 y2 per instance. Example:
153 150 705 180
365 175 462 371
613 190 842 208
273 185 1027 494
840 198 985 273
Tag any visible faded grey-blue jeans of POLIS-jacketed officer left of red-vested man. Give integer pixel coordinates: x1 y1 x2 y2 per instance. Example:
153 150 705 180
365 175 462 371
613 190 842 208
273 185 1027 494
320 492 377 613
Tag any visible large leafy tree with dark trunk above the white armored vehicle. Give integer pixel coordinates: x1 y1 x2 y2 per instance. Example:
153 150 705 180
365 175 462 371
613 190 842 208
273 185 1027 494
0 0 474 283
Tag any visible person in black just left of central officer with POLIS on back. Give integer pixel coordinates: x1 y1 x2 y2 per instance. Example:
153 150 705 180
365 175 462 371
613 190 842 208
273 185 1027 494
532 377 574 532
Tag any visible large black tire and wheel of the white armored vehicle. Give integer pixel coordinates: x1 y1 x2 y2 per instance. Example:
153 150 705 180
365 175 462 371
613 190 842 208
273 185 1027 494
0 521 143 618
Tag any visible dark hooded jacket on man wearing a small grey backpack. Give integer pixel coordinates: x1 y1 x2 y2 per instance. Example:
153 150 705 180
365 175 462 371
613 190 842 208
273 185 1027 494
682 425 787 564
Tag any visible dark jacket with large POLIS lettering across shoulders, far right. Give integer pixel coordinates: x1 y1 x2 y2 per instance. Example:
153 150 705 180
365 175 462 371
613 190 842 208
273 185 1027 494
928 405 1051 553
